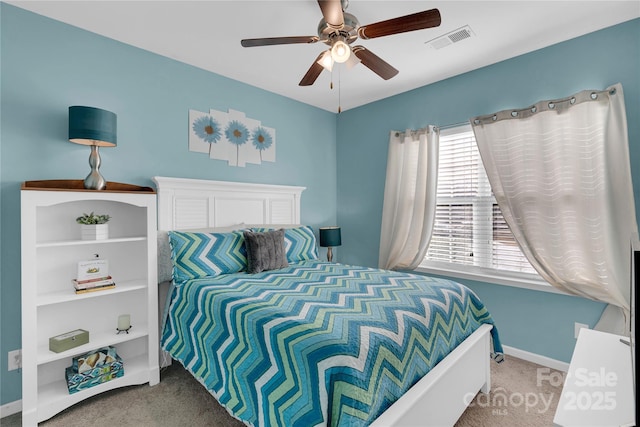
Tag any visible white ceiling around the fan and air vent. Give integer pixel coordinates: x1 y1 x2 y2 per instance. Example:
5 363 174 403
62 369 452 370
7 0 640 112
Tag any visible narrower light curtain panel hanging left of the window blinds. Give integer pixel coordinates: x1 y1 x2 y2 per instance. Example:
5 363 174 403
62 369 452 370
378 126 439 269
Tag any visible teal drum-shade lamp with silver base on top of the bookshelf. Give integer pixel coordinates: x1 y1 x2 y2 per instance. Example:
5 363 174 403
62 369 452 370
69 105 118 190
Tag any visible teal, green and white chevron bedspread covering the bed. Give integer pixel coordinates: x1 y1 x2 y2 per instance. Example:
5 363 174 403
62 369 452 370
162 260 502 427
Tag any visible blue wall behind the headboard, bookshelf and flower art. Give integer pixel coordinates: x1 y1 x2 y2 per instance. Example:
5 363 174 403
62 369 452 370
0 3 337 404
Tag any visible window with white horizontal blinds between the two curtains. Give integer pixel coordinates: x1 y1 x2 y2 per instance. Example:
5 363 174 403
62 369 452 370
421 125 540 280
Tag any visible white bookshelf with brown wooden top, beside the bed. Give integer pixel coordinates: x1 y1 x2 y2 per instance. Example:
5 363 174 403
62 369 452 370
21 181 160 426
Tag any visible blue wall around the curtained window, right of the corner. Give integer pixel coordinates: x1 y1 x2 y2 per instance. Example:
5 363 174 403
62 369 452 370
337 19 640 362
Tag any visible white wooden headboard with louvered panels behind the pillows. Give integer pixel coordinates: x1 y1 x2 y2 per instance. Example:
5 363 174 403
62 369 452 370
153 176 306 230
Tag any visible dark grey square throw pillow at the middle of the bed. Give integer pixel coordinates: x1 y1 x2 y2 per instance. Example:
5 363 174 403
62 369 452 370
244 228 289 274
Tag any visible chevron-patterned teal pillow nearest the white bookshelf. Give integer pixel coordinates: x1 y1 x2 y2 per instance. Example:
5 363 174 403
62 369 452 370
169 231 247 283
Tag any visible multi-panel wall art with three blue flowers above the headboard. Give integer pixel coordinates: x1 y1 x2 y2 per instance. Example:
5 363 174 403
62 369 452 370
189 110 276 167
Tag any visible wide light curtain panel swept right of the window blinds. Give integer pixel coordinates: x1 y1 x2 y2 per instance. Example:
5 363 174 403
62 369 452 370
471 84 637 332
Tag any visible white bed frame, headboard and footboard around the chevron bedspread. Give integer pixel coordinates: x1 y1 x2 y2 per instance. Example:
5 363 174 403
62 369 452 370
153 177 492 427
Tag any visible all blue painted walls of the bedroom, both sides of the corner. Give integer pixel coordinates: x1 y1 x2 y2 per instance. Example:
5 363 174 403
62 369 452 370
0 3 640 405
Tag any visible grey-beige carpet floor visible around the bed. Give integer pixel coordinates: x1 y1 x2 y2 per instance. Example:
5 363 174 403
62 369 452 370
0 357 562 427
